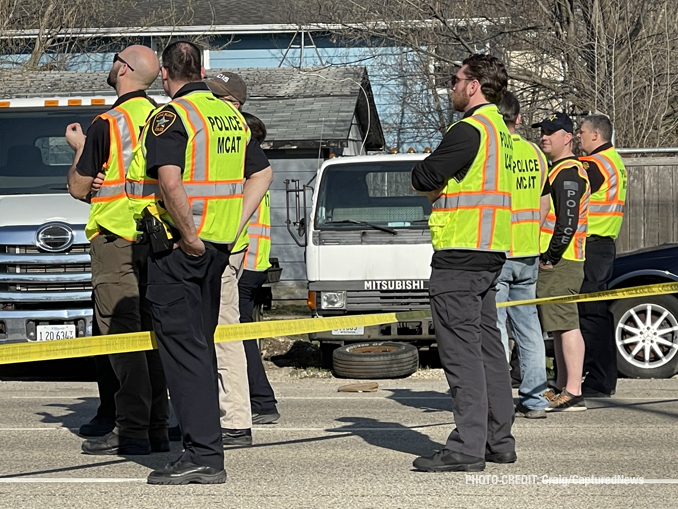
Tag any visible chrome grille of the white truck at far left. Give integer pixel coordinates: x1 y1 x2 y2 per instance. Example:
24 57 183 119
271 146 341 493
0 244 92 302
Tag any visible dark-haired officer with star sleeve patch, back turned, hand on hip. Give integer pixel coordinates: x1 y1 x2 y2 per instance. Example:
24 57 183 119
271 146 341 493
126 41 272 484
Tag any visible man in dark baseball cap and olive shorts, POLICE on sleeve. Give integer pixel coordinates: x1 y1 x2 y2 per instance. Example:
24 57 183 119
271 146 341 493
532 113 591 412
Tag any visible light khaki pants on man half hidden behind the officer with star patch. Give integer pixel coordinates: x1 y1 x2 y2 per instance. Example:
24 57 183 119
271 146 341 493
214 252 252 429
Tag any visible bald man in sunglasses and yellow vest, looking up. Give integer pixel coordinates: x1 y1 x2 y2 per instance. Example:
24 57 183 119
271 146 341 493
66 46 169 454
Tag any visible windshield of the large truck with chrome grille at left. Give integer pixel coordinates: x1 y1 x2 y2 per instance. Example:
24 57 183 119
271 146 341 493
0 106 106 195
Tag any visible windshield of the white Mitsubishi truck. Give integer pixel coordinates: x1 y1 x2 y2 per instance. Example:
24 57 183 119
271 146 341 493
315 161 431 230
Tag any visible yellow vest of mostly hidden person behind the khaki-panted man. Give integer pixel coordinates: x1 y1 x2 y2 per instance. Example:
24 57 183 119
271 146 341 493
233 191 271 272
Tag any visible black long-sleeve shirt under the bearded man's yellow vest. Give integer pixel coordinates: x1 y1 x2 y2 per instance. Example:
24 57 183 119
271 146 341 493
412 104 506 271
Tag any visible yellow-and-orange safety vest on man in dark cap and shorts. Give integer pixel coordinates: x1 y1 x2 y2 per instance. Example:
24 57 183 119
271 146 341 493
539 159 591 261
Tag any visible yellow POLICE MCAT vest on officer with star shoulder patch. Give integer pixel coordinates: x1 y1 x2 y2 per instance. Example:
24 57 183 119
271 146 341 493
125 90 250 244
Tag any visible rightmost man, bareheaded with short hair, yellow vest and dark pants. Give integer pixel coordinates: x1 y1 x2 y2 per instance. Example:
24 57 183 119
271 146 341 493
577 115 626 398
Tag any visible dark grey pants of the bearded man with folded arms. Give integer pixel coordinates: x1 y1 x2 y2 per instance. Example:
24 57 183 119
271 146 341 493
429 268 515 458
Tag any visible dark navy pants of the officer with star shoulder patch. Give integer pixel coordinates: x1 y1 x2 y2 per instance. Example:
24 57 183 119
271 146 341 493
146 242 228 469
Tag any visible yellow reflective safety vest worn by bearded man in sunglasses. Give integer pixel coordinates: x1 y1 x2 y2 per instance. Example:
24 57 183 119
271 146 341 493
429 104 513 253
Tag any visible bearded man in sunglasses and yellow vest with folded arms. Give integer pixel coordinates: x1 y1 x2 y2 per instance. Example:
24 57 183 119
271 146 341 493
412 54 516 472
